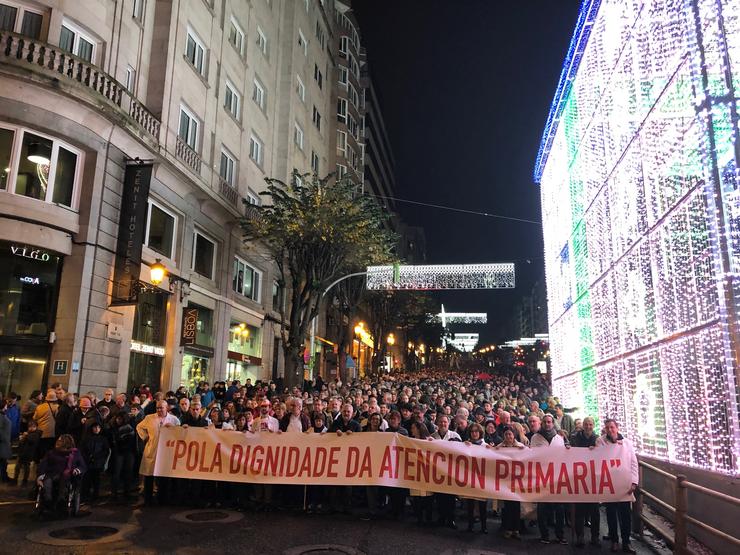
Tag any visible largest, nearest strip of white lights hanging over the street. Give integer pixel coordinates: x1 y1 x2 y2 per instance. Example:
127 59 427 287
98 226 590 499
367 263 516 290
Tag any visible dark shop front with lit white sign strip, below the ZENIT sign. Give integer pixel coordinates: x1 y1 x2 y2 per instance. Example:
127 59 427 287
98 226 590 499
126 286 169 392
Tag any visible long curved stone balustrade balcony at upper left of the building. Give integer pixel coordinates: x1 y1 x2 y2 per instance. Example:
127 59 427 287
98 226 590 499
0 31 161 143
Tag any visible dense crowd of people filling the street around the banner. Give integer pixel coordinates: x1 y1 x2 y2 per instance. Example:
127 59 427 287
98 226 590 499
0 367 637 553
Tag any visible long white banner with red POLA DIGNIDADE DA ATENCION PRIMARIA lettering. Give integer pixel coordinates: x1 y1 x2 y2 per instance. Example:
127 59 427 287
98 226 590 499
154 427 632 502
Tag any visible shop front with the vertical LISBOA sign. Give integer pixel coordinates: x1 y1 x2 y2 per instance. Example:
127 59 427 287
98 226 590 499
180 303 213 394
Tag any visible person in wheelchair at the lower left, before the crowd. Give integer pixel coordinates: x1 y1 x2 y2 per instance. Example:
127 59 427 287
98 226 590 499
36 434 87 508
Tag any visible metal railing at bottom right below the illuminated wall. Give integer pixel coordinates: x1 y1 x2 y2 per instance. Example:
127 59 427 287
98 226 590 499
635 461 740 555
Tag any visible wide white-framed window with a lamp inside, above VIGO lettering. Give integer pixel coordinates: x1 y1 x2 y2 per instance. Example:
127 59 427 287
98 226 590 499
0 126 82 208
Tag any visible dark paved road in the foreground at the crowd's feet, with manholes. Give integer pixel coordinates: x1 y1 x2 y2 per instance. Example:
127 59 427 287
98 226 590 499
0 485 668 555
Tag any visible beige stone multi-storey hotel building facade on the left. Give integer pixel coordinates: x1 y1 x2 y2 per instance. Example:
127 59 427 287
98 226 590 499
0 0 336 398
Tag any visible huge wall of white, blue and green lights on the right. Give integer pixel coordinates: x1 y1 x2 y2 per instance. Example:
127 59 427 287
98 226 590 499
535 0 740 475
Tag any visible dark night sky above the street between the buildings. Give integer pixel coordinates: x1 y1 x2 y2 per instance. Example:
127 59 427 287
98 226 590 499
353 0 580 343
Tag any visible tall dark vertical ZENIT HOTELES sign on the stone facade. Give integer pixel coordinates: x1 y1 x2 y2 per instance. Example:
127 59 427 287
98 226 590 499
111 164 152 305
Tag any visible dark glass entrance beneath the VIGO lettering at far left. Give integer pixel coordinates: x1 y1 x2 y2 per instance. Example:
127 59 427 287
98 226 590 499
0 241 66 399
